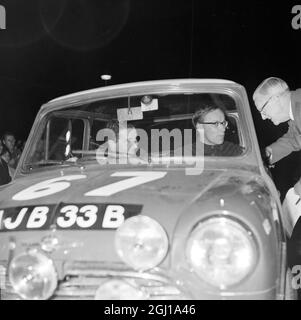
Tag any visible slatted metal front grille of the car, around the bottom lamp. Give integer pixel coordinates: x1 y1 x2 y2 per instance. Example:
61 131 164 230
52 262 188 300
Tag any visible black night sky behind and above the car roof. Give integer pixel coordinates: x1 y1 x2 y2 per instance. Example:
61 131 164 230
0 0 301 196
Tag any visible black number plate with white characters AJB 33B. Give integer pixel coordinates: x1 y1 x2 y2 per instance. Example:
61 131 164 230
0 203 142 232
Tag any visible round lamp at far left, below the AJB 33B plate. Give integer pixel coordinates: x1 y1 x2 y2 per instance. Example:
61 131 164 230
8 251 57 300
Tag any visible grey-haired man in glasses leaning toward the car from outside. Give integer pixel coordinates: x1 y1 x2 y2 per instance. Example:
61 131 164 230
253 77 301 272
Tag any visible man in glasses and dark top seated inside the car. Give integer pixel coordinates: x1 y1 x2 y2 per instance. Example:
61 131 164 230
192 105 243 157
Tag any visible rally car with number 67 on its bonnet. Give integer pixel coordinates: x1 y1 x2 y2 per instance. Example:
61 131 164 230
0 79 294 300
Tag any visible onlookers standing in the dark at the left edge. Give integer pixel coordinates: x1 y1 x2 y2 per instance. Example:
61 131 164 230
0 132 24 185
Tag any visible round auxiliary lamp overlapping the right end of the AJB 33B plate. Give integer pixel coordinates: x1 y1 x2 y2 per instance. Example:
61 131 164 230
115 216 168 271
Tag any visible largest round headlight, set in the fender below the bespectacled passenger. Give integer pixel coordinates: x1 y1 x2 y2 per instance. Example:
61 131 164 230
186 217 257 289
